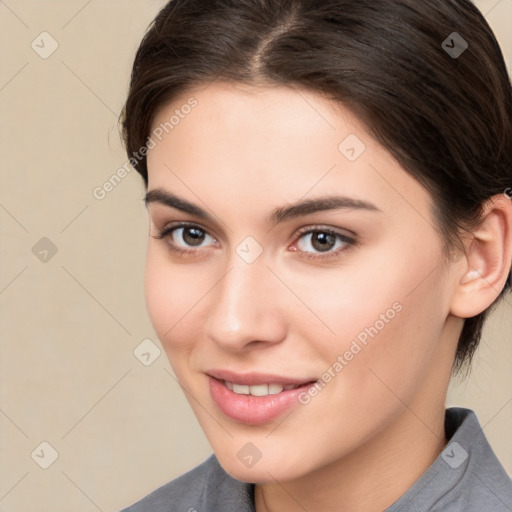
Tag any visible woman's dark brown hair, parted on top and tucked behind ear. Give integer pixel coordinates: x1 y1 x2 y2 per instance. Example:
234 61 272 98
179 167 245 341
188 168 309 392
121 0 512 376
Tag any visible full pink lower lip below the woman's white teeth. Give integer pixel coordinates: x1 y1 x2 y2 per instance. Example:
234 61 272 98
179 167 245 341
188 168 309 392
208 376 314 425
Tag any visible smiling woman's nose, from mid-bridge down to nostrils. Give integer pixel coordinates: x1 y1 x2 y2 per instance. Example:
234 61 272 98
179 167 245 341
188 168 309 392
206 255 287 352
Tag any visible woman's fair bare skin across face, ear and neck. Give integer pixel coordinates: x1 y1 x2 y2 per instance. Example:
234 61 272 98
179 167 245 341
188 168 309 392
141 82 512 512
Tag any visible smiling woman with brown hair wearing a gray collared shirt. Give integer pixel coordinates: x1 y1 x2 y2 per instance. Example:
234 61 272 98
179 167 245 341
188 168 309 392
123 0 512 512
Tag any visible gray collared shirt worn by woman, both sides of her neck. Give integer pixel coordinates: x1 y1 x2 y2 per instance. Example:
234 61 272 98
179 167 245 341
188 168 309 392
121 407 512 512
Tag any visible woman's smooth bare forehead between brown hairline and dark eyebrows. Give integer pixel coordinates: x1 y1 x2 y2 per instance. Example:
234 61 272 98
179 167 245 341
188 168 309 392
148 82 430 227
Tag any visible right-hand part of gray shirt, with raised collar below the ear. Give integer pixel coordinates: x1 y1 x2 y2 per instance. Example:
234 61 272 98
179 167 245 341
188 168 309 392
386 407 512 512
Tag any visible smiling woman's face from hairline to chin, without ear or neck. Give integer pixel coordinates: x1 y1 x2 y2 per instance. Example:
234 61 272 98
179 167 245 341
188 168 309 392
146 83 461 482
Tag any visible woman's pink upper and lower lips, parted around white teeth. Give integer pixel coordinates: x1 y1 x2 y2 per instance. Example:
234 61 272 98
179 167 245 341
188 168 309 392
207 371 316 425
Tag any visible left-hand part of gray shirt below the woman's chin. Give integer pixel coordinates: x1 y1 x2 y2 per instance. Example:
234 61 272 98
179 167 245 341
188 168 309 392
120 454 252 512
